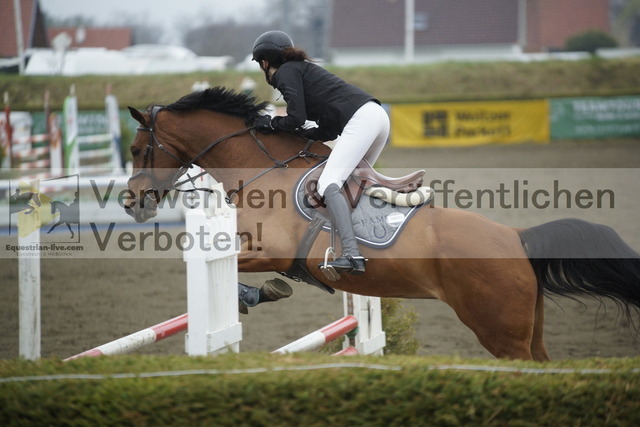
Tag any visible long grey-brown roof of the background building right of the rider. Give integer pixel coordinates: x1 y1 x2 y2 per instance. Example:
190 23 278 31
331 0 518 48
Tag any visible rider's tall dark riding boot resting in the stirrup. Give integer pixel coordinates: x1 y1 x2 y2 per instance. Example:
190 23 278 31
324 184 365 274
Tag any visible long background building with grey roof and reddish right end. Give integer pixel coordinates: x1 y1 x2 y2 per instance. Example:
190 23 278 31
329 0 610 65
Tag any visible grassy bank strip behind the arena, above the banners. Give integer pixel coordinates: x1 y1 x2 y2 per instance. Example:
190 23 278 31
0 57 640 111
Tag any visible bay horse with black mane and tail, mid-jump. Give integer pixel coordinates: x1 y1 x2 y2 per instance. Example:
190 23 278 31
125 87 640 361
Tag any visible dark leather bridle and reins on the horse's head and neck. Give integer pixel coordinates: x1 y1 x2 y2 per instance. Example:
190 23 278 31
127 105 325 202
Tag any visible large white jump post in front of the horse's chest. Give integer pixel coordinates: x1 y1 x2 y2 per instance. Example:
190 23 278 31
184 185 242 356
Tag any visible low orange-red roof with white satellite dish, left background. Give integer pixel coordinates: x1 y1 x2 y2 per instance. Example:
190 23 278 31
49 27 133 50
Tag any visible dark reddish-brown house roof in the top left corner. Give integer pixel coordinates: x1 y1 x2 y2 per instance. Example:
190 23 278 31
0 0 49 58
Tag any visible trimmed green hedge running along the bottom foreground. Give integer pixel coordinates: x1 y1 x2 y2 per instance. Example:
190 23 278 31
0 354 640 426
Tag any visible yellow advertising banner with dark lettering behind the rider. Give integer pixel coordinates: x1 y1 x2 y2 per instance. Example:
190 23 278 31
391 100 550 147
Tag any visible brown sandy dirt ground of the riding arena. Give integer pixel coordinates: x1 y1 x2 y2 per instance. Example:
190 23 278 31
0 140 640 359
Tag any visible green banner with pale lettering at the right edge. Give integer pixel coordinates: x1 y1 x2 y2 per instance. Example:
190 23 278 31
550 96 640 139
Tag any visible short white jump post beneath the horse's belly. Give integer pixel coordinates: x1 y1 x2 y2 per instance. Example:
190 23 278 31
343 292 386 356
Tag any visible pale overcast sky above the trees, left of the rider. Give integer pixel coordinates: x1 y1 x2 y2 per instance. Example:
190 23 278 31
40 0 266 42
